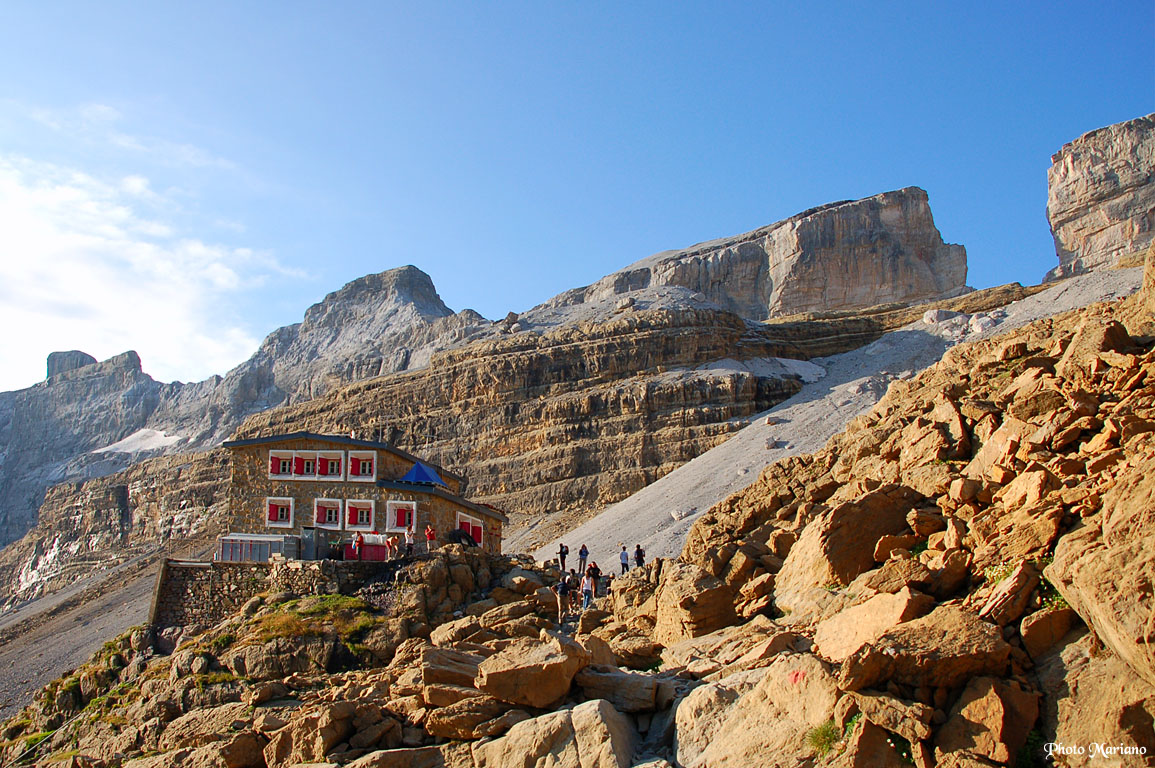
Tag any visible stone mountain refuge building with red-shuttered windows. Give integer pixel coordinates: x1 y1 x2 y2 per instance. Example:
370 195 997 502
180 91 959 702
216 432 508 561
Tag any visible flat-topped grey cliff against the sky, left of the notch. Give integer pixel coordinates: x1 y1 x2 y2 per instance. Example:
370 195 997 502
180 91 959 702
547 187 967 320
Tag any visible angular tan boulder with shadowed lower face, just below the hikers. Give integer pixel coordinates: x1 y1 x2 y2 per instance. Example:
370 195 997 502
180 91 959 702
474 631 589 708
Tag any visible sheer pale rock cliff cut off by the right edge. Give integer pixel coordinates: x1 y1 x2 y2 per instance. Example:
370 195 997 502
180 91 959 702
1046 114 1155 279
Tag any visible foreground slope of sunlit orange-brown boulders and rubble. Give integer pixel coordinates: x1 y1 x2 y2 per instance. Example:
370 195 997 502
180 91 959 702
0 249 1155 768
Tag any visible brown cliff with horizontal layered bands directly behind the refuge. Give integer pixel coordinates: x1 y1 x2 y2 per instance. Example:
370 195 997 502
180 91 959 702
231 311 798 515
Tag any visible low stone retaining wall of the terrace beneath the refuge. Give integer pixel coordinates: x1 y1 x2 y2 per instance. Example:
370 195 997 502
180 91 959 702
149 560 404 629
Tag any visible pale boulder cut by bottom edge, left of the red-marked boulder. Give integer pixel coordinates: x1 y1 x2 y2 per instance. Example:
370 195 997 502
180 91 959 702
472 700 636 768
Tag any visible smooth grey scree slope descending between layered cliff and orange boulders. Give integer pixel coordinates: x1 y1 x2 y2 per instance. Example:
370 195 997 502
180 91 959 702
528 269 1142 571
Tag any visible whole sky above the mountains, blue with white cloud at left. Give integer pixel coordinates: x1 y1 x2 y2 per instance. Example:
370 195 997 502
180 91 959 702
0 0 1155 389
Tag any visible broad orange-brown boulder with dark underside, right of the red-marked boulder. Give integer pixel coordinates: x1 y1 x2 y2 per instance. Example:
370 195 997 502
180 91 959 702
839 605 1011 691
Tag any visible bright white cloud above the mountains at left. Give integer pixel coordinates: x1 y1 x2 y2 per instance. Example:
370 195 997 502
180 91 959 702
0 154 296 390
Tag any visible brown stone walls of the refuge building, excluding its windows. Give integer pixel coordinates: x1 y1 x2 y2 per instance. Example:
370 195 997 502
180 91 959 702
225 433 505 553
